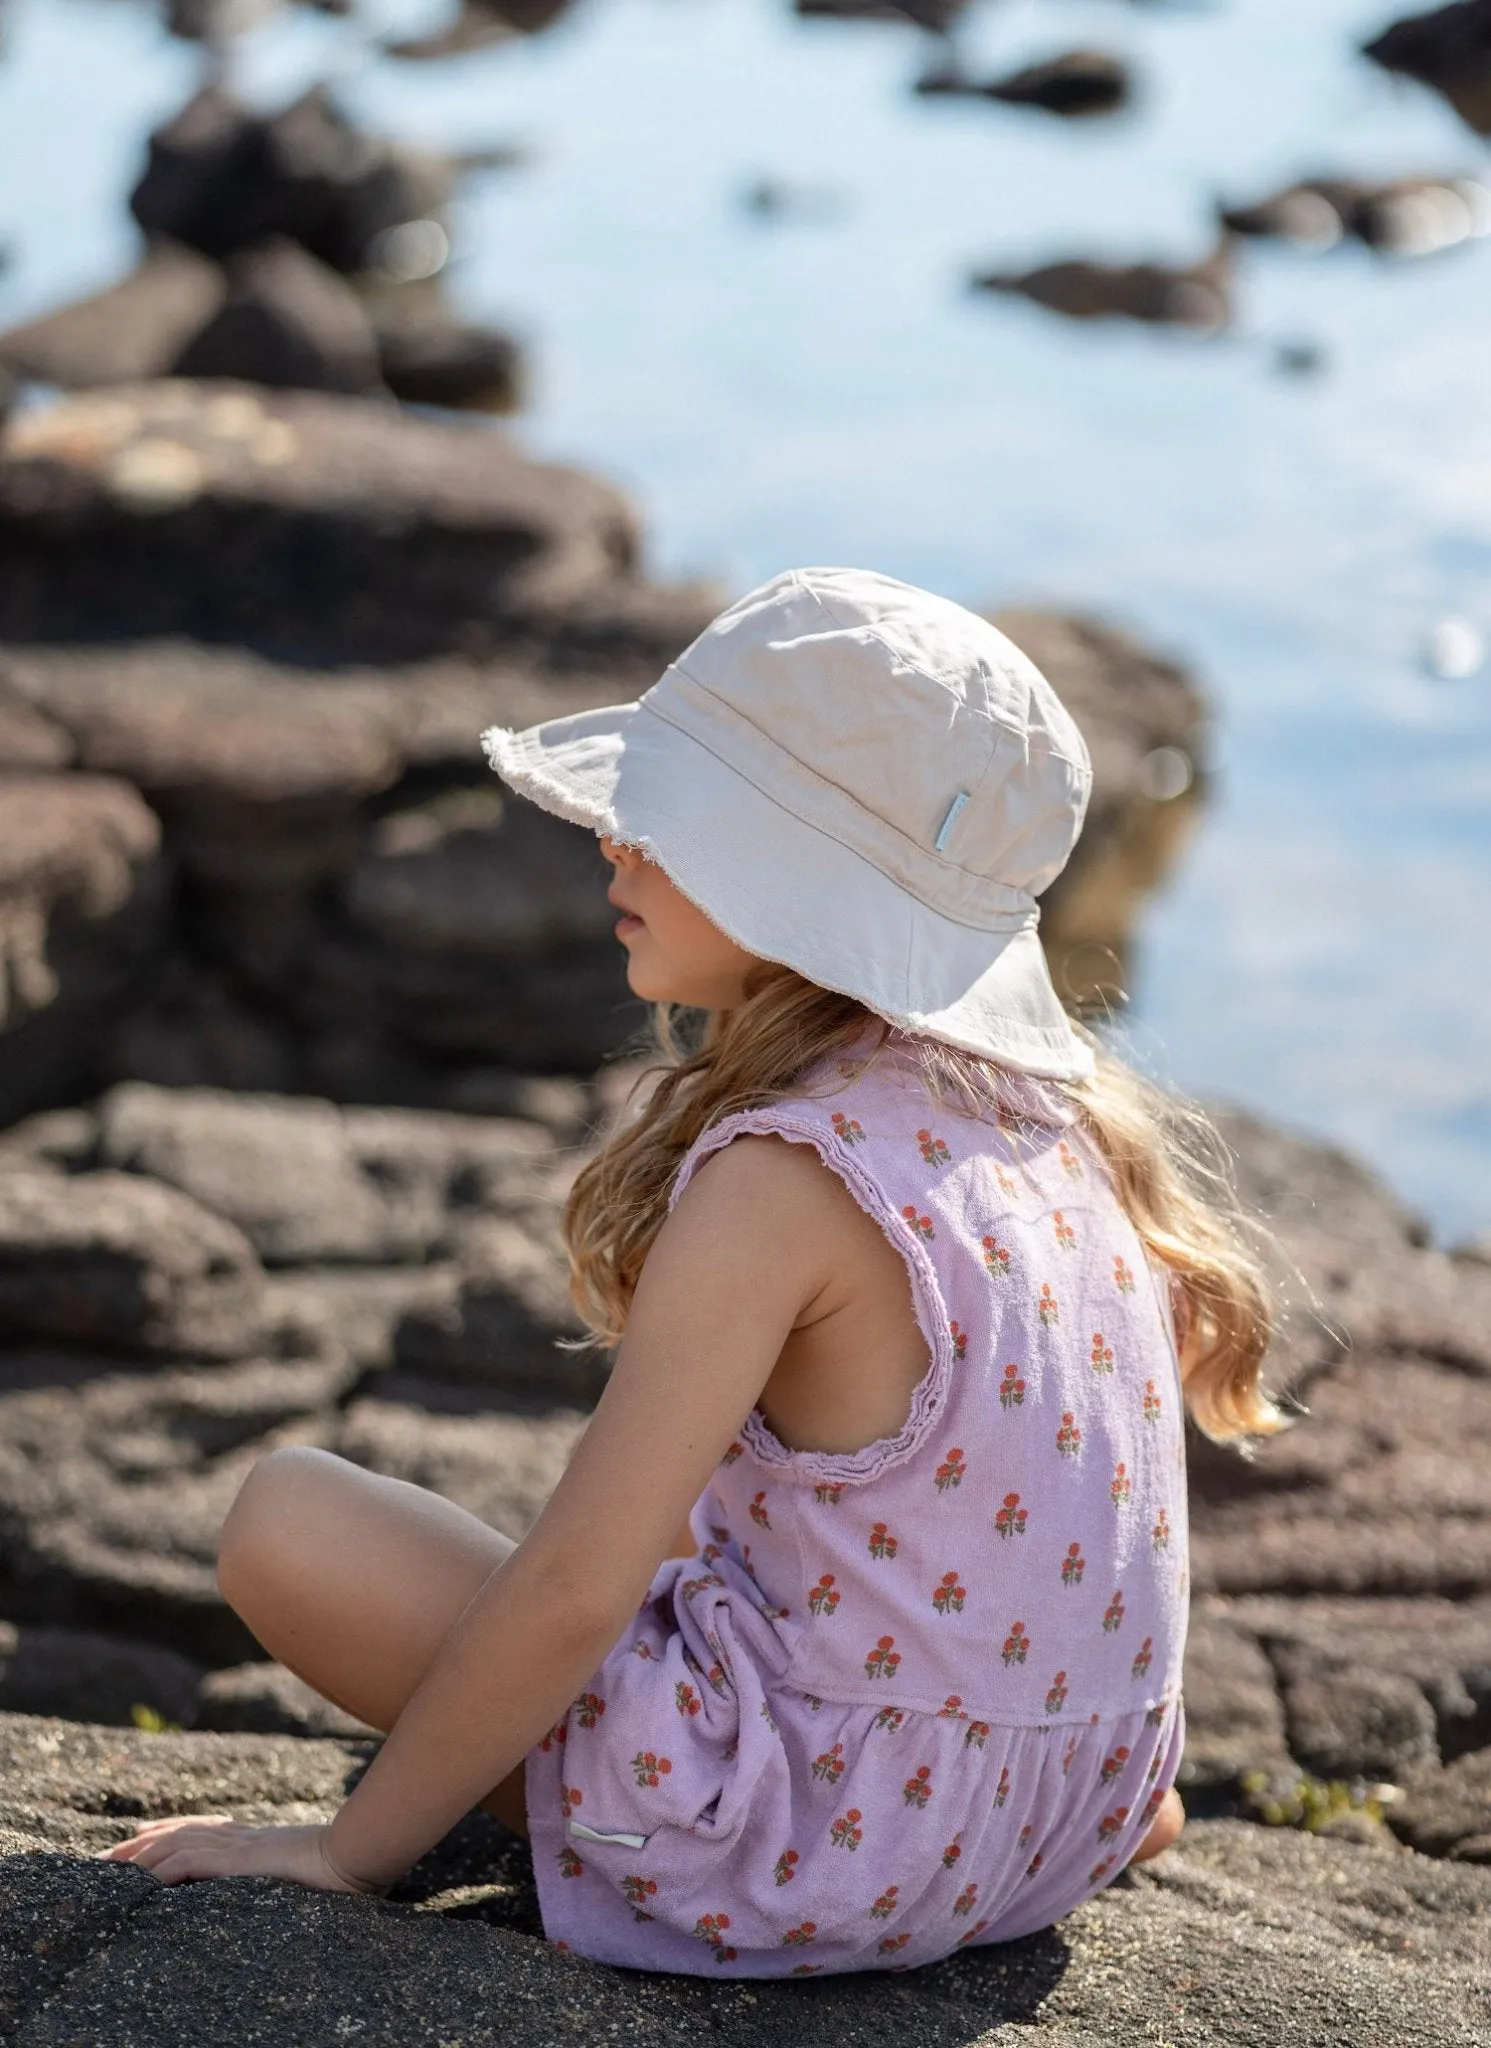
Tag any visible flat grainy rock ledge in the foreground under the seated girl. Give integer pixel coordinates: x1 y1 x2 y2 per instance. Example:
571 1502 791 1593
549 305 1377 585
0 1714 1491 2048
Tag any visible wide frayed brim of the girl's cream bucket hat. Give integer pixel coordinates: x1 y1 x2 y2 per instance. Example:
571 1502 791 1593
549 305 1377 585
481 702 1094 1081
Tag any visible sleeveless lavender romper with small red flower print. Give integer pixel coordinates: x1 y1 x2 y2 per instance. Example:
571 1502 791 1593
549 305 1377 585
526 1040 1186 1976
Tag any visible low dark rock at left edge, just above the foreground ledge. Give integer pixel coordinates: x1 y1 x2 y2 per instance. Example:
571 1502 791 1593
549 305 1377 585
0 1622 200 1728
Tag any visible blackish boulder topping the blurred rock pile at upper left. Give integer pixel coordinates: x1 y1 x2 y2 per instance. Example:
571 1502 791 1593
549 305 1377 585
129 86 449 272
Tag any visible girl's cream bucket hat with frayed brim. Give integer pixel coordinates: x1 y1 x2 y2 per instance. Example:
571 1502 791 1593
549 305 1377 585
481 569 1092 1079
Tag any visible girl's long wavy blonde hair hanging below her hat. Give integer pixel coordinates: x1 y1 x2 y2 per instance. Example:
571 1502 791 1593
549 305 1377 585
563 961 1284 1442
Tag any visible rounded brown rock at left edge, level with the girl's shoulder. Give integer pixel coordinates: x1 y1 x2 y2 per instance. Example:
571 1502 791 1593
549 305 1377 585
0 1169 264 1358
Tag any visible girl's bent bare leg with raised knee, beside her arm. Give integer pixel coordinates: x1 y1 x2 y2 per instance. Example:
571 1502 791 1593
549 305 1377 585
217 1448 528 1835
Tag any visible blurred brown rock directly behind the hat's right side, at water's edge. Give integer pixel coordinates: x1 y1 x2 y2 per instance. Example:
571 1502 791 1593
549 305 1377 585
991 606 1208 1010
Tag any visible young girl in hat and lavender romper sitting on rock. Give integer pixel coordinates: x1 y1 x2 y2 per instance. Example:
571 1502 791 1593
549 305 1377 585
98 569 1276 1976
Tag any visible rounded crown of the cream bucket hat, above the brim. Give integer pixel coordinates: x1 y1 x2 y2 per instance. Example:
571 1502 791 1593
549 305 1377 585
643 569 1092 913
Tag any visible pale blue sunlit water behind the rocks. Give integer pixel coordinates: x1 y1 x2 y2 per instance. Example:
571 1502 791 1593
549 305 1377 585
0 0 1491 1241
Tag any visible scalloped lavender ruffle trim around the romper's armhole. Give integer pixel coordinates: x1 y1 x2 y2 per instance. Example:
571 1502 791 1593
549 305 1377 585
668 1106 952 1485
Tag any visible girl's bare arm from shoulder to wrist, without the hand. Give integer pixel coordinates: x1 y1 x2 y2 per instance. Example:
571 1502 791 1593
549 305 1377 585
311 1139 829 1886
